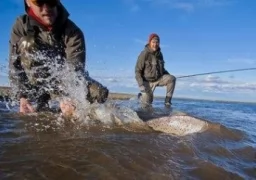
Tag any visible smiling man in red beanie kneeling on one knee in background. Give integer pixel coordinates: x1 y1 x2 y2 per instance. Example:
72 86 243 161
135 33 176 106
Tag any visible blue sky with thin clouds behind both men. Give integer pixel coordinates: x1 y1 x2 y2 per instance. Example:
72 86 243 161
0 0 256 102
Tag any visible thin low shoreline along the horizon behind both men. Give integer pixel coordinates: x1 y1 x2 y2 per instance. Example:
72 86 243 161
0 86 256 104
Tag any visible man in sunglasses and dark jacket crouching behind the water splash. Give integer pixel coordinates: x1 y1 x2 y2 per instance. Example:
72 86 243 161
9 0 108 113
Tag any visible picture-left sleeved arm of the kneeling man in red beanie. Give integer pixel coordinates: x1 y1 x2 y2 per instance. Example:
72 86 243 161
135 51 146 87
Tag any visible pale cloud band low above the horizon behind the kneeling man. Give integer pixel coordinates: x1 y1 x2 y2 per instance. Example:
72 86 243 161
91 67 256 95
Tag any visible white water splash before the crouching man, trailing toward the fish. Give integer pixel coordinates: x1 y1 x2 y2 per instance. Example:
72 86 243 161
6 51 144 125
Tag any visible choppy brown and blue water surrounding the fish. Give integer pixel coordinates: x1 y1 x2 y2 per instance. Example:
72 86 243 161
0 97 256 179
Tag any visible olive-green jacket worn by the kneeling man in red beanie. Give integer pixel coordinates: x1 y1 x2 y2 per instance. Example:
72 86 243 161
135 44 169 86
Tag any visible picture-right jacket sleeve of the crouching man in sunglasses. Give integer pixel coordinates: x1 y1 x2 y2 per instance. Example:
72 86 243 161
65 21 86 74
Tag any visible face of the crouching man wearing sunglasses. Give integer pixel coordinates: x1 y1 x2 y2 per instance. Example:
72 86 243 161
26 0 59 25
